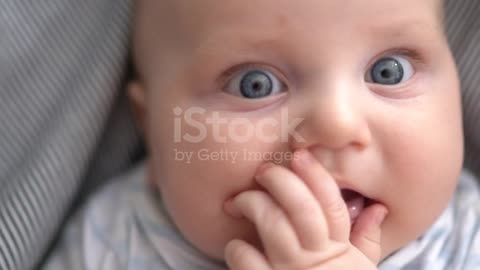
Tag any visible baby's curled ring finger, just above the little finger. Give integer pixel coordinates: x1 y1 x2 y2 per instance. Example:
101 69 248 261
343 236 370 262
233 190 300 262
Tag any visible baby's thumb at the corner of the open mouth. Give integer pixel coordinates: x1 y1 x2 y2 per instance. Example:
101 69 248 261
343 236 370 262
350 204 388 265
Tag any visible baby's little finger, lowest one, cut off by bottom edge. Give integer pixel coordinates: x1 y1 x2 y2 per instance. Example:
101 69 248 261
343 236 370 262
225 239 271 270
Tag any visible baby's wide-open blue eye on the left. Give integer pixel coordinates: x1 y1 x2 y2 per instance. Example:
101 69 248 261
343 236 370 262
227 69 283 99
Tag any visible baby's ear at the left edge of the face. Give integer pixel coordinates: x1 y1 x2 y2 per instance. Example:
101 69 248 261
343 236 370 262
127 81 147 134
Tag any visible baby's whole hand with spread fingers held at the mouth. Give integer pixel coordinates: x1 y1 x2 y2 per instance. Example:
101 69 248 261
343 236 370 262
225 150 387 270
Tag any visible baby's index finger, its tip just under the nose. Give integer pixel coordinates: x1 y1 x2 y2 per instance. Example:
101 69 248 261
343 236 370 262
292 149 350 242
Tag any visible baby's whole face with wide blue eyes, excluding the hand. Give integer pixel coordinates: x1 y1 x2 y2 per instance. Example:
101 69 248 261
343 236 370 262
132 0 463 259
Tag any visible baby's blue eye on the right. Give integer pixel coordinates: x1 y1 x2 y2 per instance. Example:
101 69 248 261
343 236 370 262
366 56 414 85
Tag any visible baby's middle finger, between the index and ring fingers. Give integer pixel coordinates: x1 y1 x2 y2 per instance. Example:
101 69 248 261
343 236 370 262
256 161 329 250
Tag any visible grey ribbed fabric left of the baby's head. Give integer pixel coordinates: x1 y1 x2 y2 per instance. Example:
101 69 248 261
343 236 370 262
0 0 138 270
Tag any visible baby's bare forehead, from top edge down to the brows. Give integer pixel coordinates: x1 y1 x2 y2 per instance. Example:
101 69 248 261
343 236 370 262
134 0 443 76
